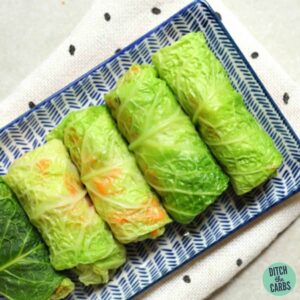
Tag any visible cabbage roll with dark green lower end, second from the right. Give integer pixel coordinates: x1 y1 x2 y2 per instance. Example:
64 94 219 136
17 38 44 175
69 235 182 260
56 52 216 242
105 65 228 223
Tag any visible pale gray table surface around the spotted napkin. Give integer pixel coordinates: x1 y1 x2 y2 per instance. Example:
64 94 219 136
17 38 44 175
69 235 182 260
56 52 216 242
0 0 300 300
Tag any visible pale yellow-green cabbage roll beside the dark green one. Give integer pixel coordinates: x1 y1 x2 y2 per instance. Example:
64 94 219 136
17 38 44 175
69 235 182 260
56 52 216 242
3 140 125 284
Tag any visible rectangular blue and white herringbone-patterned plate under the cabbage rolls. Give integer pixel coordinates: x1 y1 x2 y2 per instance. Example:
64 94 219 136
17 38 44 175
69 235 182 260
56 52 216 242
0 0 300 299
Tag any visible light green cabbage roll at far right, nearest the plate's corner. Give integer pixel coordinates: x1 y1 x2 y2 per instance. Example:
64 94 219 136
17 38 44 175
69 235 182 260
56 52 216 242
152 32 282 195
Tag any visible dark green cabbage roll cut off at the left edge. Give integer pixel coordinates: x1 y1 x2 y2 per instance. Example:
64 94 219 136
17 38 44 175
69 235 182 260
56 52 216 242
0 178 74 300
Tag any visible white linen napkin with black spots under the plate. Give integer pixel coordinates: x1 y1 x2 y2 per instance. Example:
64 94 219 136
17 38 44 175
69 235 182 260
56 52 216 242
0 0 300 300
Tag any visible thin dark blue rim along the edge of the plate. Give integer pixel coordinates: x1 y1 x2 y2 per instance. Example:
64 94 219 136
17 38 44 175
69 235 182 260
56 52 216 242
0 0 300 299
